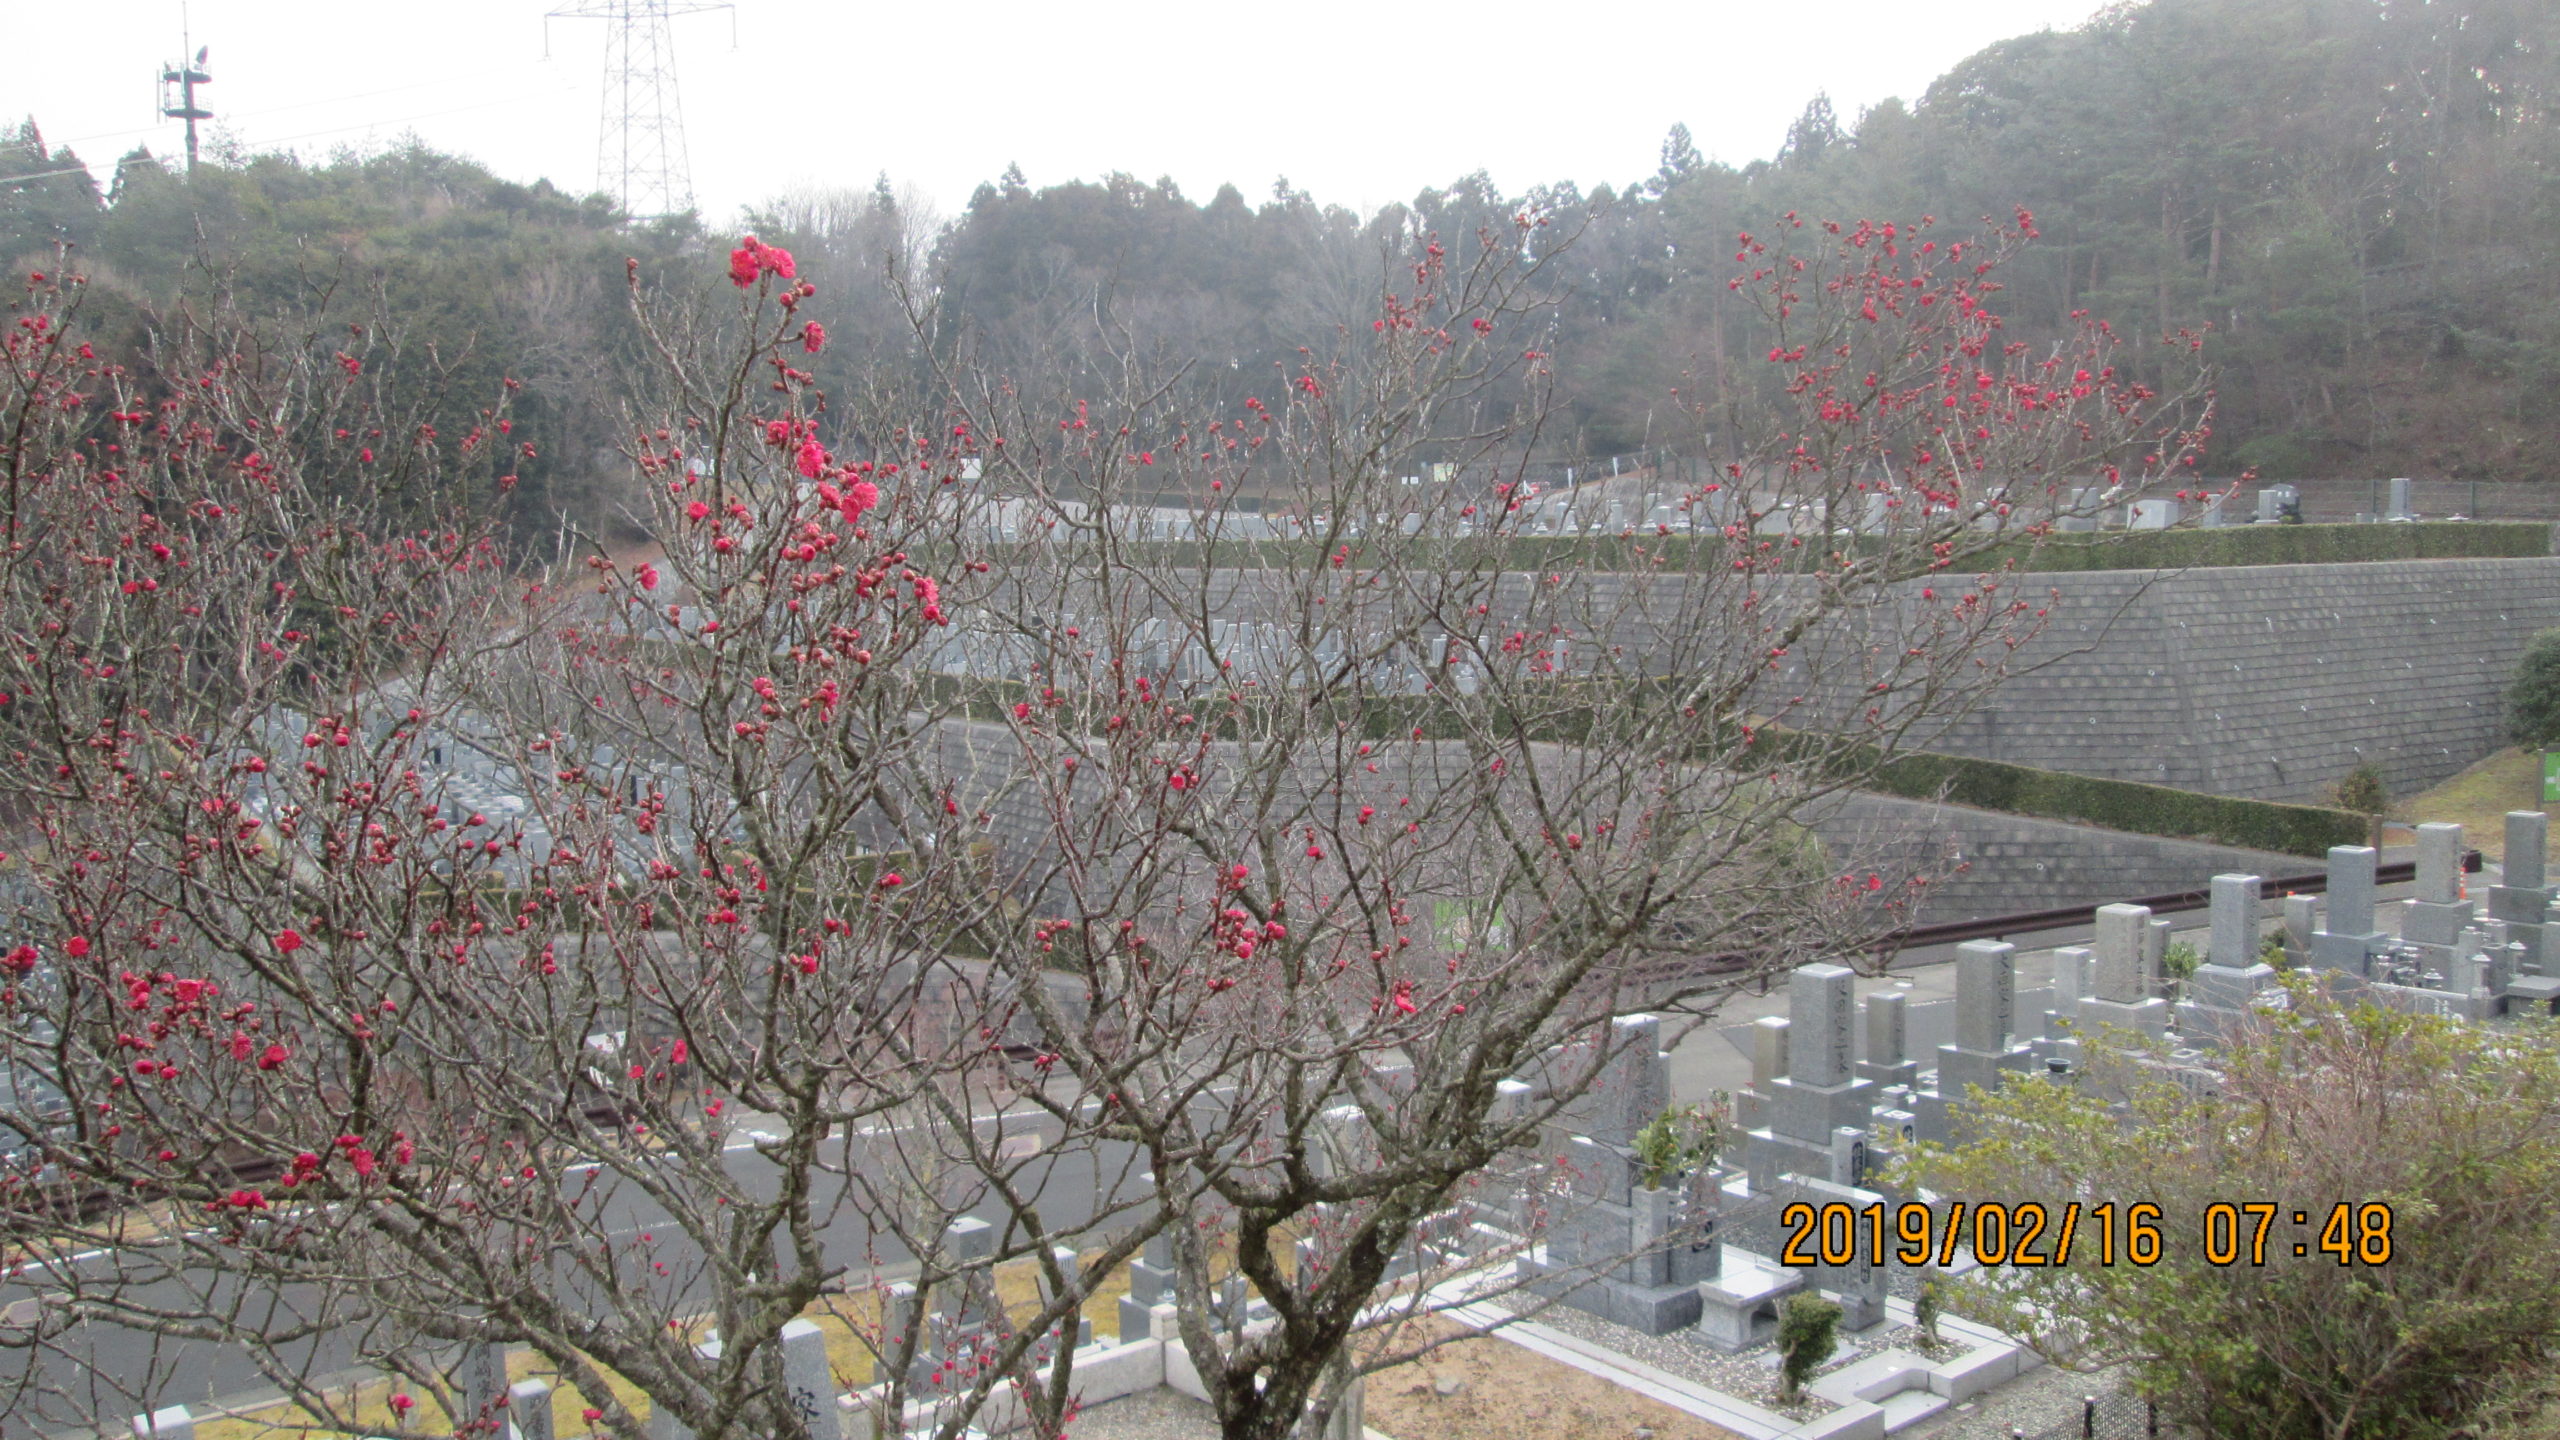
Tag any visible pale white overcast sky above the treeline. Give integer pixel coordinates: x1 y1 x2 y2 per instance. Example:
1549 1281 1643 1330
0 0 2097 225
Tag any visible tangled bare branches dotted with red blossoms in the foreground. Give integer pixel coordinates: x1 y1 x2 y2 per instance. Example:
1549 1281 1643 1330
0 218 2196 1440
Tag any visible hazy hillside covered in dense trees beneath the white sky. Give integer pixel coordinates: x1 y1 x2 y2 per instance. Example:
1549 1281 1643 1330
0 0 2560 538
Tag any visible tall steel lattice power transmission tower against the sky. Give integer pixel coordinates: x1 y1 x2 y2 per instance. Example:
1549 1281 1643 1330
543 0 735 220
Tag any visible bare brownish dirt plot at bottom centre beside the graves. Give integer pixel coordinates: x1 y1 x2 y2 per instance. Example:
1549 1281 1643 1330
1364 1335 1741 1440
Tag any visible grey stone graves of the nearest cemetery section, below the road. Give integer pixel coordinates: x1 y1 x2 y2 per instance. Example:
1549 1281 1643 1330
115 794 2560 1440
